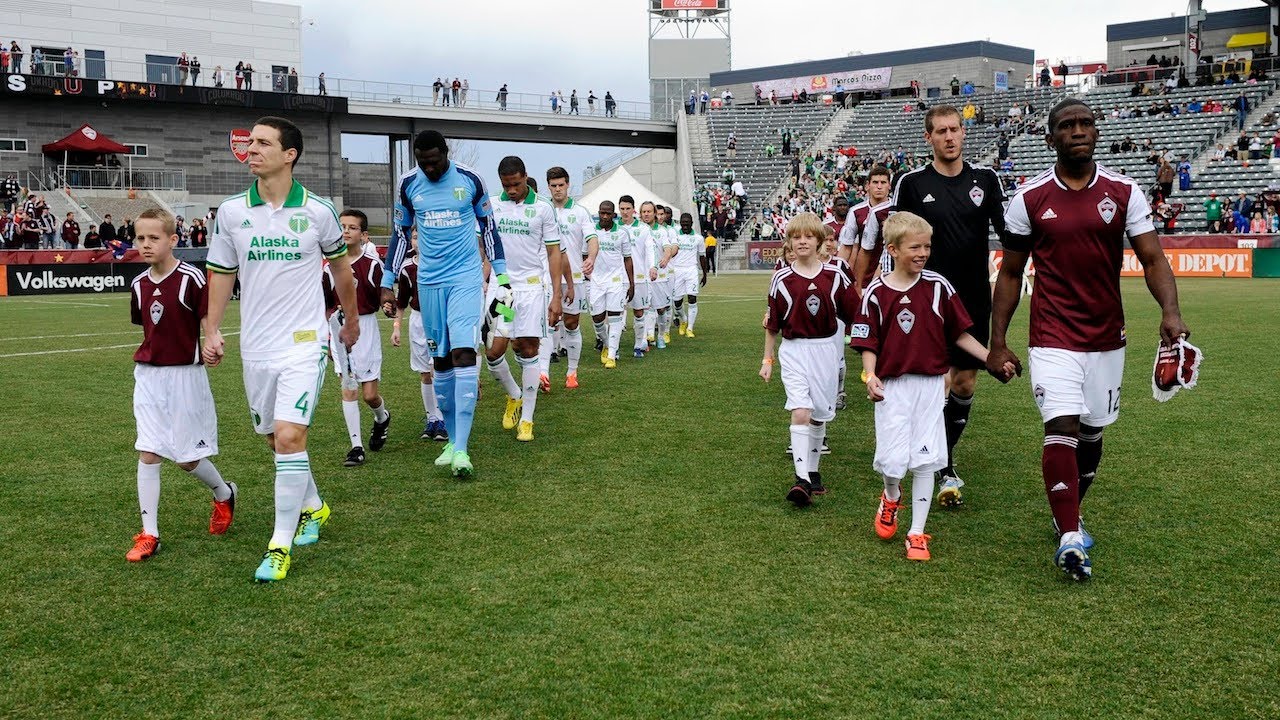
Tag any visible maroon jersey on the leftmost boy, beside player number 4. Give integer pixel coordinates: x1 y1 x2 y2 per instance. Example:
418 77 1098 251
129 261 209 365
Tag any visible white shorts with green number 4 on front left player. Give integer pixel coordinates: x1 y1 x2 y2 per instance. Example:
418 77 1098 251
244 346 329 436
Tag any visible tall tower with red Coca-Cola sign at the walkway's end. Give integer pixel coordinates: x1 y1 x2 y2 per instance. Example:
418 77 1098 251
645 0 732 117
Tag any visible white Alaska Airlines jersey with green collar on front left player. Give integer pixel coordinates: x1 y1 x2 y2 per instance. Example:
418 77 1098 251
206 181 347 360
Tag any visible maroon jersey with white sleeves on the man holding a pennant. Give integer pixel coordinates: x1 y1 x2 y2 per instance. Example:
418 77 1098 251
1005 165 1156 352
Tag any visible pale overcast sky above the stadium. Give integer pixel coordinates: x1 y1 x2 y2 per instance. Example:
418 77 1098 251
301 0 1262 190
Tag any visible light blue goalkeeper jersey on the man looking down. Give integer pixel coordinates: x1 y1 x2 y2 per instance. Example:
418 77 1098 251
383 163 504 288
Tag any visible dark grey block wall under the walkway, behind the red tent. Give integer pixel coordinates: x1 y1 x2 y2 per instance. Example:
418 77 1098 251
0 97 343 205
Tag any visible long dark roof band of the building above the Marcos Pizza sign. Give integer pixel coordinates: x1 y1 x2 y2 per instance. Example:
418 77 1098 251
710 40 1036 86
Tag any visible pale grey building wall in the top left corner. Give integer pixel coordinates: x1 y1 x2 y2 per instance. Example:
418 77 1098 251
5 0 306 87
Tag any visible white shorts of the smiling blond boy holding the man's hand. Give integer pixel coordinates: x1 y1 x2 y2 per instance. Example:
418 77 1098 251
872 375 947 478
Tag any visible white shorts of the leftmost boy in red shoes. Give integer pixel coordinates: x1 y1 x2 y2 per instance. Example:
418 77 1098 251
133 363 218 462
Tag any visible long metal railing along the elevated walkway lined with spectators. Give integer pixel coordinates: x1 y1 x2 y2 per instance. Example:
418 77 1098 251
3 59 675 120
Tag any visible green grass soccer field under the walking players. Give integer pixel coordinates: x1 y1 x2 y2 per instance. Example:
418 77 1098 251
0 274 1280 719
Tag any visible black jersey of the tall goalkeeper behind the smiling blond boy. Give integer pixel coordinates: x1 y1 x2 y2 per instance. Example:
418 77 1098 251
890 163 1005 298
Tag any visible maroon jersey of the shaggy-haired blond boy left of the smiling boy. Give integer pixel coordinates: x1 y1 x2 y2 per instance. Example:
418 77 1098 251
765 264 855 340
